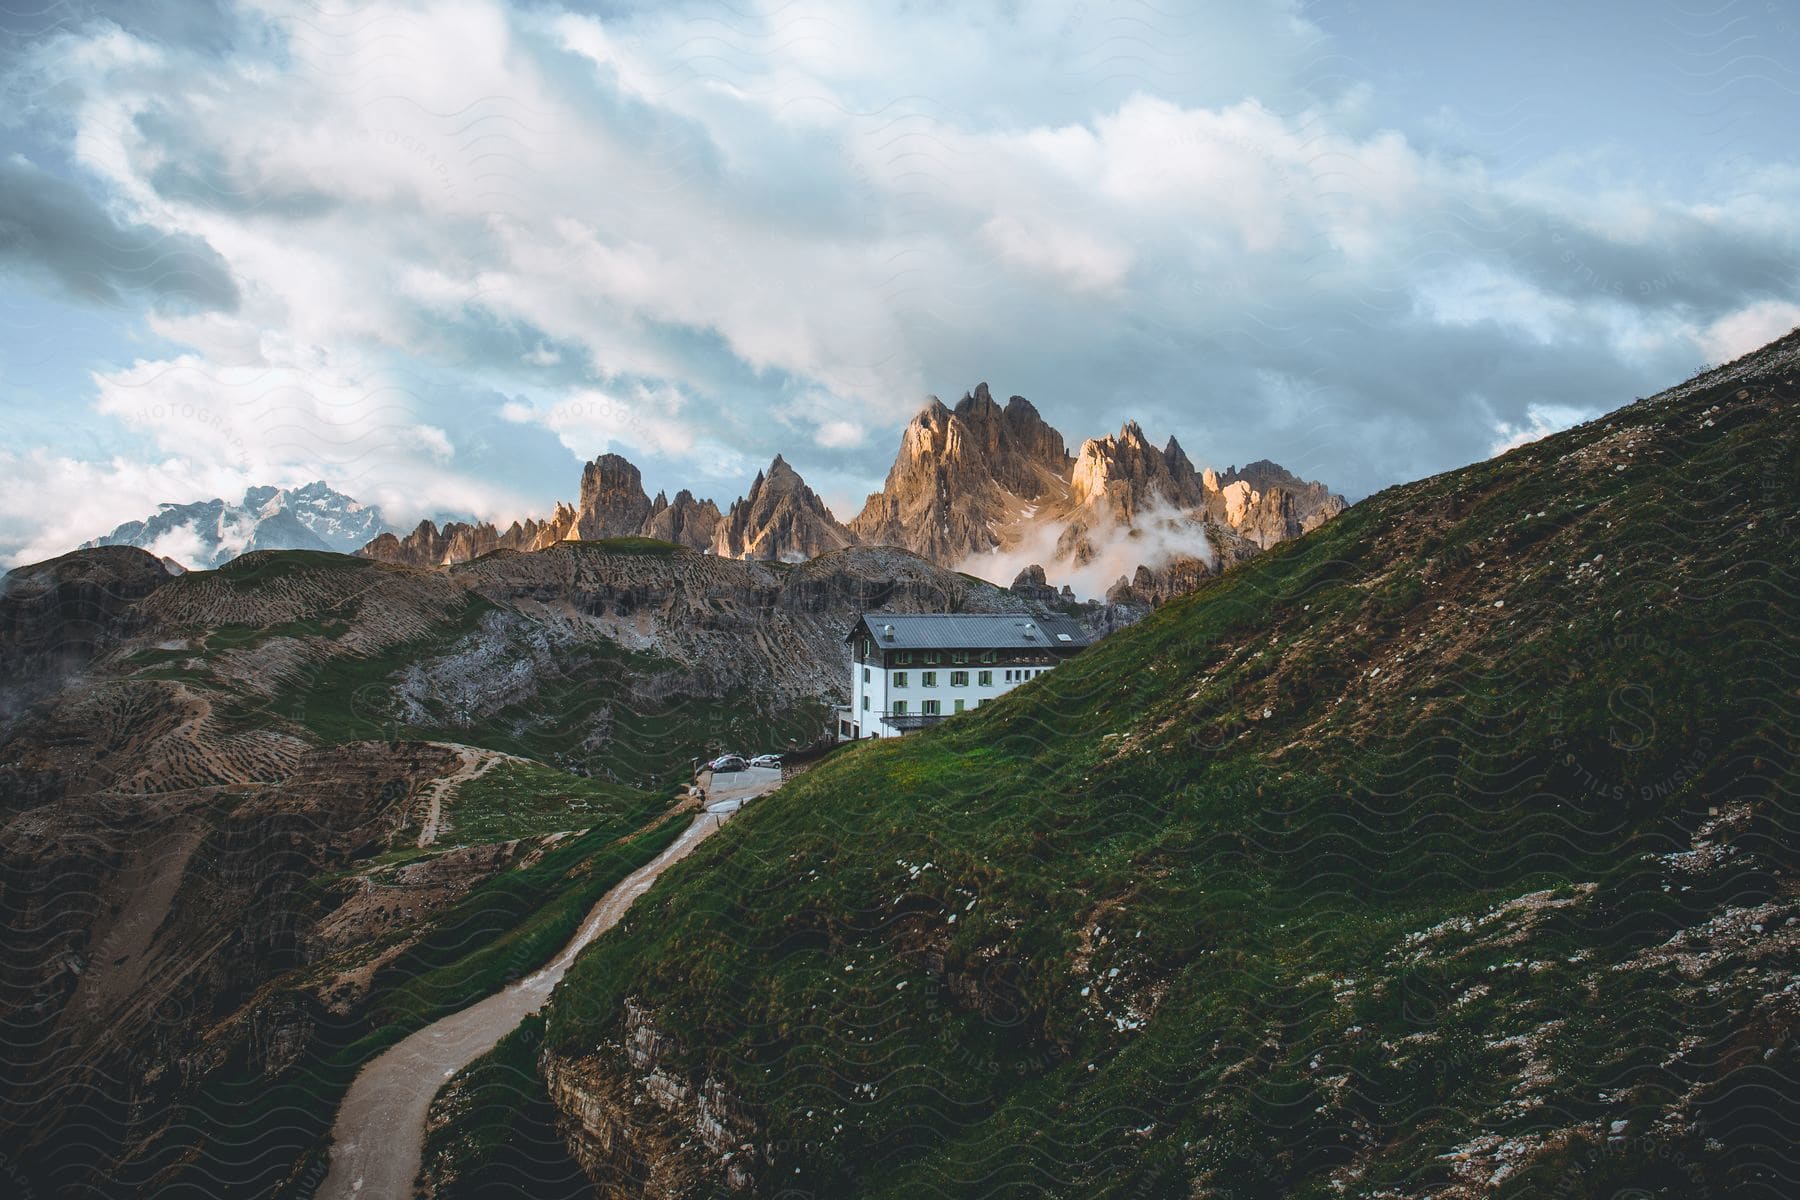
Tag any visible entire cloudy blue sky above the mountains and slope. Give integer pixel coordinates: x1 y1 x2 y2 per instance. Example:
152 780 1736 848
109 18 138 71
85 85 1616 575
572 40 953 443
0 0 1800 565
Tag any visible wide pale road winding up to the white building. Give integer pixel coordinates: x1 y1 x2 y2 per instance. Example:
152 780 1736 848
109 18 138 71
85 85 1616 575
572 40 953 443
315 772 781 1200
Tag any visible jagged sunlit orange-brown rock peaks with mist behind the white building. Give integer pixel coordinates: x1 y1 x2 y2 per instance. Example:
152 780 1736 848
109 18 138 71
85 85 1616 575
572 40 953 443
360 383 1345 604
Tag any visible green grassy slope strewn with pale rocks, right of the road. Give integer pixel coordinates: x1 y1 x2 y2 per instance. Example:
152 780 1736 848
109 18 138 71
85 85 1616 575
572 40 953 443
549 338 1800 1196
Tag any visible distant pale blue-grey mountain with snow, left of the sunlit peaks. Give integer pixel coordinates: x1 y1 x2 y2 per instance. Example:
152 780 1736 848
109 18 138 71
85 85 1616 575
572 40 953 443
83 480 389 570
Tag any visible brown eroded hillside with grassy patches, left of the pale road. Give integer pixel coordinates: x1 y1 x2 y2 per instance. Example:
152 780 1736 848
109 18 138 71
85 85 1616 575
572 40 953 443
0 540 1051 1195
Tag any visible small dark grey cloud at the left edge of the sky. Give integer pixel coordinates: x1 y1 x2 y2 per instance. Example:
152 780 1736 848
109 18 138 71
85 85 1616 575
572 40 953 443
0 158 238 311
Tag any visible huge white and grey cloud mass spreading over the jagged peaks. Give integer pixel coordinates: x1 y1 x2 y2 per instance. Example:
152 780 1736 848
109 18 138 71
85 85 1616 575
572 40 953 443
3 0 1800 564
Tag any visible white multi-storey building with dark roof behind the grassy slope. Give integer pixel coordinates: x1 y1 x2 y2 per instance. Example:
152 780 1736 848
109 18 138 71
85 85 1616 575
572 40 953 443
837 612 1089 741
